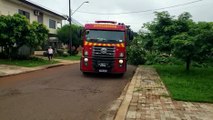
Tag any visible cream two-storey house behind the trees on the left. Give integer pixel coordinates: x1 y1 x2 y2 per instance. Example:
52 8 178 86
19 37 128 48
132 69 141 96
0 0 79 47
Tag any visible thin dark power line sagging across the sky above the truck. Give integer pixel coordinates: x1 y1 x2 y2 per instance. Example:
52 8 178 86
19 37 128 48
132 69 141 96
73 0 203 15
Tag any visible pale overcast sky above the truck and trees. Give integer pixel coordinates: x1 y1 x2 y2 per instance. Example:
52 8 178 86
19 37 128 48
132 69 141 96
30 0 213 32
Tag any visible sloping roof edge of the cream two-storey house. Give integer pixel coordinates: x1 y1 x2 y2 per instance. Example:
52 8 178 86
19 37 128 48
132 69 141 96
18 0 67 19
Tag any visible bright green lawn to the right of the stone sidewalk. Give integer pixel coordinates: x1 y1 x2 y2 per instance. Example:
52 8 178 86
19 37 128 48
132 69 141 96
154 65 213 103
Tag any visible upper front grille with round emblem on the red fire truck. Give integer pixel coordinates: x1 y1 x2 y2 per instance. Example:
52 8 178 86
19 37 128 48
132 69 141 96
92 46 115 58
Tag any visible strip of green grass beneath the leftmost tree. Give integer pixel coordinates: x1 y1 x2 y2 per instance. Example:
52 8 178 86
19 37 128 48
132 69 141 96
0 58 58 67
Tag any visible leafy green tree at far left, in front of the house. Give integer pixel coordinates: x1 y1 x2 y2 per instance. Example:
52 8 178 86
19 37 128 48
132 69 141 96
0 14 30 57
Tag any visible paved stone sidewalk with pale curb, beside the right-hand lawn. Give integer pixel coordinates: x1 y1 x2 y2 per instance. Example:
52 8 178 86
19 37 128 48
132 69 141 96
115 67 213 120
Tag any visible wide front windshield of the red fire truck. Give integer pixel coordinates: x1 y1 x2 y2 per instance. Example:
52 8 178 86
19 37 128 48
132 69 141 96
86 30 125 43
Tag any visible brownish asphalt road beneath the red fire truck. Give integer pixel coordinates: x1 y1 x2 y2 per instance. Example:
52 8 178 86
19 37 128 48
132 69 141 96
0 64 135 120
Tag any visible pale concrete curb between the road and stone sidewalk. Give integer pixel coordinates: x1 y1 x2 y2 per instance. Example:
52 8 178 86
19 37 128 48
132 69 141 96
114 67 140 120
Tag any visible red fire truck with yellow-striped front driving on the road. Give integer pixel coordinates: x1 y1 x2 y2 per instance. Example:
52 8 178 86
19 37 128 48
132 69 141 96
80 21 133 75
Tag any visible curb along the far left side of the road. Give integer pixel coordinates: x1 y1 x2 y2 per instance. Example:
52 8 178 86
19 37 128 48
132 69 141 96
0 61 80 78
